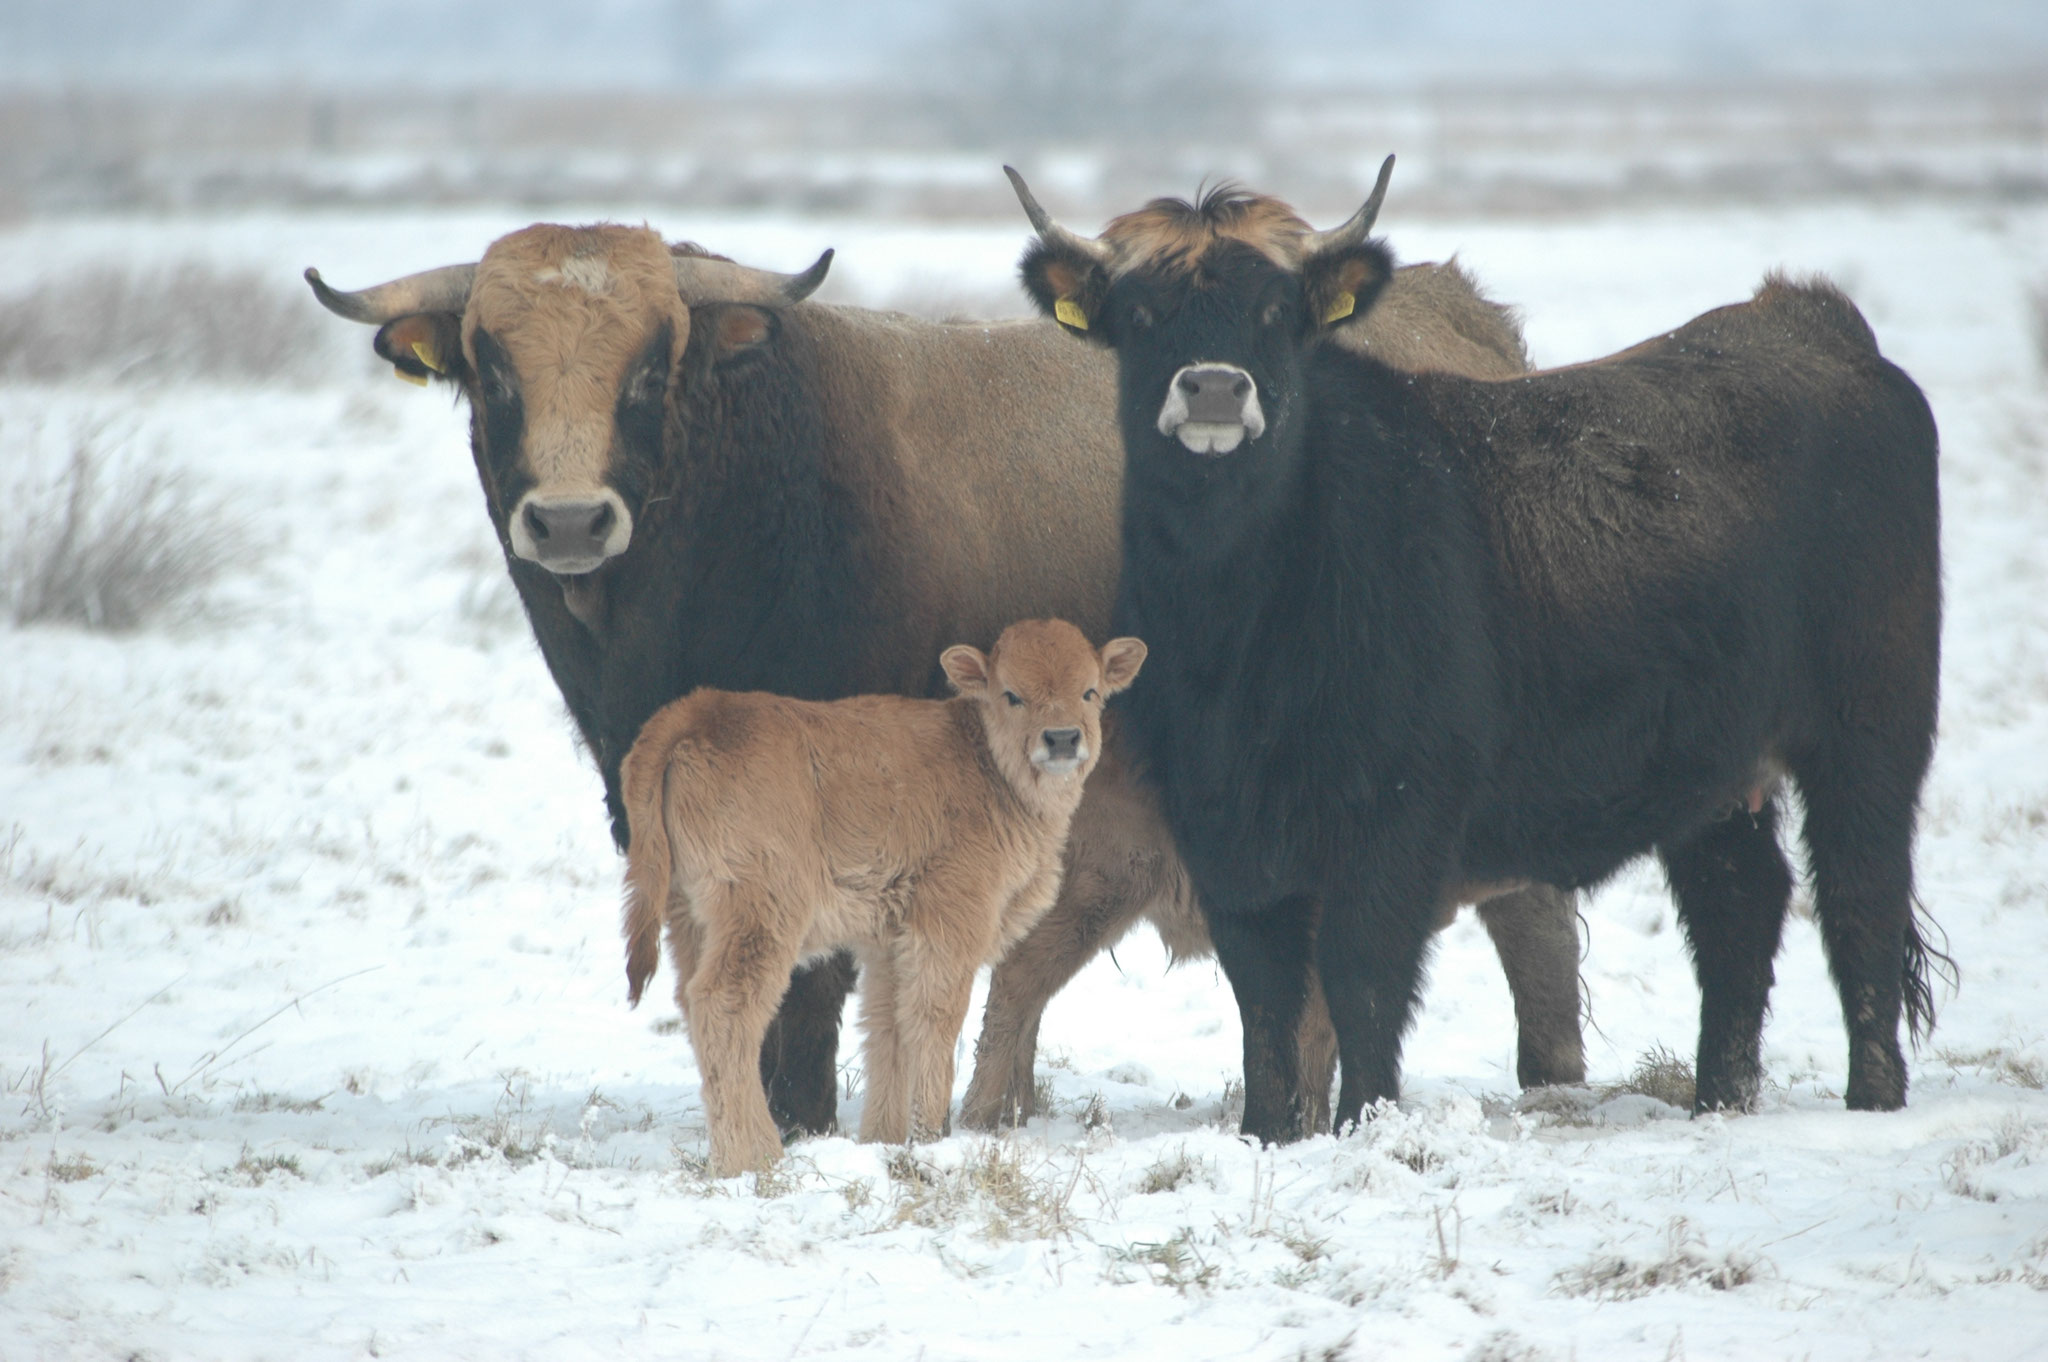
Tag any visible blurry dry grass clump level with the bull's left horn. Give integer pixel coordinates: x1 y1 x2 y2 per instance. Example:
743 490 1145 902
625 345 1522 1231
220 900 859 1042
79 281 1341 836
0 260 334 383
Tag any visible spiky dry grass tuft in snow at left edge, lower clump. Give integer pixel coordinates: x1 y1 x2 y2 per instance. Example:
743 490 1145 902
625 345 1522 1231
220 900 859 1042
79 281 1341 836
0 424 248 631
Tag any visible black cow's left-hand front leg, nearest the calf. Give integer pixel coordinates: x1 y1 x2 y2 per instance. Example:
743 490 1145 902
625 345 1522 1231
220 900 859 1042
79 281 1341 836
1206 895 1318 1145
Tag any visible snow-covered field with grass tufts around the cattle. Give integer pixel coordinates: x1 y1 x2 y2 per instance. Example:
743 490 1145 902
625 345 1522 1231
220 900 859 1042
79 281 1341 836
12 193 2048 1362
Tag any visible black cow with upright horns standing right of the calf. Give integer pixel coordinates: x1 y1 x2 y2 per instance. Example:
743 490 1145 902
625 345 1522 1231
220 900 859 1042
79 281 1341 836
1018 158 1942 1141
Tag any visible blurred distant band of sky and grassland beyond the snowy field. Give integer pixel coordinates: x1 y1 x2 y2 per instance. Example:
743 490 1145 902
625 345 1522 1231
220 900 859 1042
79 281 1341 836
0 0 2048 219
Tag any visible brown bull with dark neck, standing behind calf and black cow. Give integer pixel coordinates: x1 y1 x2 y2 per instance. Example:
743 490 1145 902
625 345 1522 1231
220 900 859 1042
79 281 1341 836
307 199 1583 1131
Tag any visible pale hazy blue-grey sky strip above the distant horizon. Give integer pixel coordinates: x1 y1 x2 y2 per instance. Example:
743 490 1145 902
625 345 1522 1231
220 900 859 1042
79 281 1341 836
12 0 2048 88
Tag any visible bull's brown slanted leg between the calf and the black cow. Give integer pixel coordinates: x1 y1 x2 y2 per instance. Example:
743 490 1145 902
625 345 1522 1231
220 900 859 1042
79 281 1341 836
961 848 1149 1131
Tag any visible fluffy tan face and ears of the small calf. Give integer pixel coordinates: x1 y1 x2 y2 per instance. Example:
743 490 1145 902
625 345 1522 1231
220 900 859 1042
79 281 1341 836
938 621 1145 797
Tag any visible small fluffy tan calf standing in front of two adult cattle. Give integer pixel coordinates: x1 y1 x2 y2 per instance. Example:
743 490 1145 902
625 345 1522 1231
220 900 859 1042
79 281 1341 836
623 621 1145 1176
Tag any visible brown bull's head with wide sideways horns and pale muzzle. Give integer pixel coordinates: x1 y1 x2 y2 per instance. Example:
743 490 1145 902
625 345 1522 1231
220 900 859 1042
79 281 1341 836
307 223 831 578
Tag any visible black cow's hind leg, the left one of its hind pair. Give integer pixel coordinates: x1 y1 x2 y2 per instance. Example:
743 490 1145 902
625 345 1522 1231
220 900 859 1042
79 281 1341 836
1657 803 1792 1112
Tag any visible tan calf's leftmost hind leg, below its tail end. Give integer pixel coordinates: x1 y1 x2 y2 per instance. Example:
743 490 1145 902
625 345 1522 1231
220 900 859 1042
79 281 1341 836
684 885 797 1178
